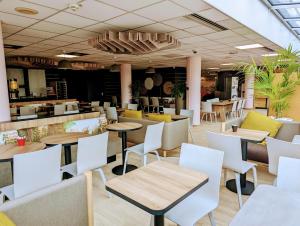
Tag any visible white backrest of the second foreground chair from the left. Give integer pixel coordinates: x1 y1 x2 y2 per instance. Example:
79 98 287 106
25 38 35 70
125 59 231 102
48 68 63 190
77 132 108 174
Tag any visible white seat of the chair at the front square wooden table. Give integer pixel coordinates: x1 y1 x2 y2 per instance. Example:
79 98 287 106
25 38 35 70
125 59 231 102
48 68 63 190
165 192 218 225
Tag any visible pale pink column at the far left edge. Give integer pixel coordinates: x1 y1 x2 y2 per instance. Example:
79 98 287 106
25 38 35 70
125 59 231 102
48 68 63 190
0 21 10 122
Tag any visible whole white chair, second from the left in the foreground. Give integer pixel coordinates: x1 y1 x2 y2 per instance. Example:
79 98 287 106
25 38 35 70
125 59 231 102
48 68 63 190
61 132 110 196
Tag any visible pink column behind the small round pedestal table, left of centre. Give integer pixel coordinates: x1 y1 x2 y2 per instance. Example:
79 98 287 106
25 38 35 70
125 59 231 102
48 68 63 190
121 64 132 104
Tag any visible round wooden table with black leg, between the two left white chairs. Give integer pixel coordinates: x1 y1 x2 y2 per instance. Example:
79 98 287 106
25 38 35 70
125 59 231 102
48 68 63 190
41 132 89 165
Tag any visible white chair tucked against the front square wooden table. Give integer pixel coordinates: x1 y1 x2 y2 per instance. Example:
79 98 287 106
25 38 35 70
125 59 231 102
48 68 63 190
165 143 224 226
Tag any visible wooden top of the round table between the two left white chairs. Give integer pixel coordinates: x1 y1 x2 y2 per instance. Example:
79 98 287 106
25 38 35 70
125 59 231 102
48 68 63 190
41 133 89 145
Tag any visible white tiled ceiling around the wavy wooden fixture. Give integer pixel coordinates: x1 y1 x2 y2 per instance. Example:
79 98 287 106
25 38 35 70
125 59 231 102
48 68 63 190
0 0 279 69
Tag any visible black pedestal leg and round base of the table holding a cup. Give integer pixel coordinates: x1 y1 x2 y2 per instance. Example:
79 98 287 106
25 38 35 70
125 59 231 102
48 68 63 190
226 140 254 195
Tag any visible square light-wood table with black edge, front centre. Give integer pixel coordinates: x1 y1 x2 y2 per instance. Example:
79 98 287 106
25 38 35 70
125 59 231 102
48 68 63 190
105 161 208 226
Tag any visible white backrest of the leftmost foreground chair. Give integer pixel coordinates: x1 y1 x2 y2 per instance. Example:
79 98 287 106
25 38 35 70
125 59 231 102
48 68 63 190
14 145 61 198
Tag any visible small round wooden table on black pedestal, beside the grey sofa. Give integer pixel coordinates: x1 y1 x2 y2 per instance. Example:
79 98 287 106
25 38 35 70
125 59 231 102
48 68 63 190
106 122 143 175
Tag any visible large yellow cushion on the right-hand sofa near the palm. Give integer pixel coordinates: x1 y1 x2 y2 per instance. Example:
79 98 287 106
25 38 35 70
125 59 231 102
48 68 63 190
241 111 282 137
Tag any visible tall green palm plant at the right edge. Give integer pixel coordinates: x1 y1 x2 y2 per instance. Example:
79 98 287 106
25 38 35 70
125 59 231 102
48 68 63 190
236 45 300 117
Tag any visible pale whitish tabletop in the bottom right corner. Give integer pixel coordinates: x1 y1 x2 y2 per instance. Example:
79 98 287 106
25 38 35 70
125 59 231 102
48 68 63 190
229 185 300 226
